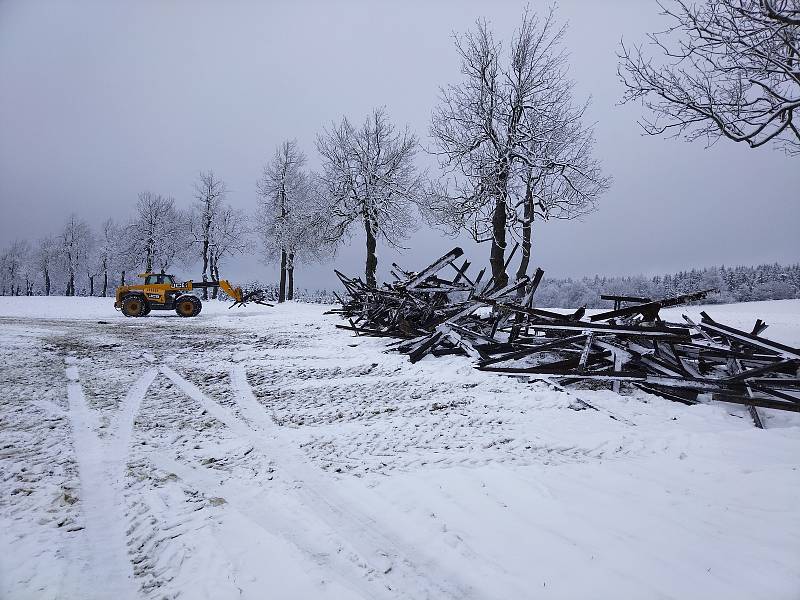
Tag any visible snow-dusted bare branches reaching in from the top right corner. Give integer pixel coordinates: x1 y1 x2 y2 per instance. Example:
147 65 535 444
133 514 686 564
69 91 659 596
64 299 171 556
619 0 800 154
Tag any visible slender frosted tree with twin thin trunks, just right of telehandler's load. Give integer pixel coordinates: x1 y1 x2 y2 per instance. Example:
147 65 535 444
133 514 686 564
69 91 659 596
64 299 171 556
256 140 325 302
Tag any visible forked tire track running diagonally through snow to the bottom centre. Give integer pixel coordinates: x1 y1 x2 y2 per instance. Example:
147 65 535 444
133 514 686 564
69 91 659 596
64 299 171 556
160 365 476 599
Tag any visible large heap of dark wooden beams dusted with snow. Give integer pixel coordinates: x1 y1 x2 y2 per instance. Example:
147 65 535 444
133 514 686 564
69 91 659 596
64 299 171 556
332 248 800 427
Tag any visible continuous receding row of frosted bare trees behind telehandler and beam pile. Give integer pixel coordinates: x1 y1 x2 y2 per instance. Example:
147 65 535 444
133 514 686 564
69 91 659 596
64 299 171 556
10 11 609 299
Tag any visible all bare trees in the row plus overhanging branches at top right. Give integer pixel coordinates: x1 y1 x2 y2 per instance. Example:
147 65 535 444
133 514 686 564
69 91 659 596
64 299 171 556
0 0 800 300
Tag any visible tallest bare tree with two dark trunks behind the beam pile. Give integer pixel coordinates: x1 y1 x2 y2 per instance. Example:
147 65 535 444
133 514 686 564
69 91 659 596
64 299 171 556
428 10 608 286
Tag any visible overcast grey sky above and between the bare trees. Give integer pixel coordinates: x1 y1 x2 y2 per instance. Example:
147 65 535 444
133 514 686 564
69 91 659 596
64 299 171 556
0 0 800 287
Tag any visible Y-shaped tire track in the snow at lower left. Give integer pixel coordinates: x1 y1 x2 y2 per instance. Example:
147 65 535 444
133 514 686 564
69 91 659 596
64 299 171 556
66 365 157 600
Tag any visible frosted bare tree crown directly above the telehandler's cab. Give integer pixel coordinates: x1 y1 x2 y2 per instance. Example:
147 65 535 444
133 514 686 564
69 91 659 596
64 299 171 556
125 192 189 273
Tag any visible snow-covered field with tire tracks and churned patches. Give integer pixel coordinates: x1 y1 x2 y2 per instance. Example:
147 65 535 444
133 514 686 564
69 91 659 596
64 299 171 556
0 298 800 600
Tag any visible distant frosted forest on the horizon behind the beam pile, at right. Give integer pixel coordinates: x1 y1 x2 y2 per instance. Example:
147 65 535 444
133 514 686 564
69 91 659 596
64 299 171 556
534 263 800 308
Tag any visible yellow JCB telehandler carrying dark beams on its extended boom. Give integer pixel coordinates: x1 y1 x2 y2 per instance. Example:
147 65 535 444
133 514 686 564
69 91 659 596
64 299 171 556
114 271 272 317
